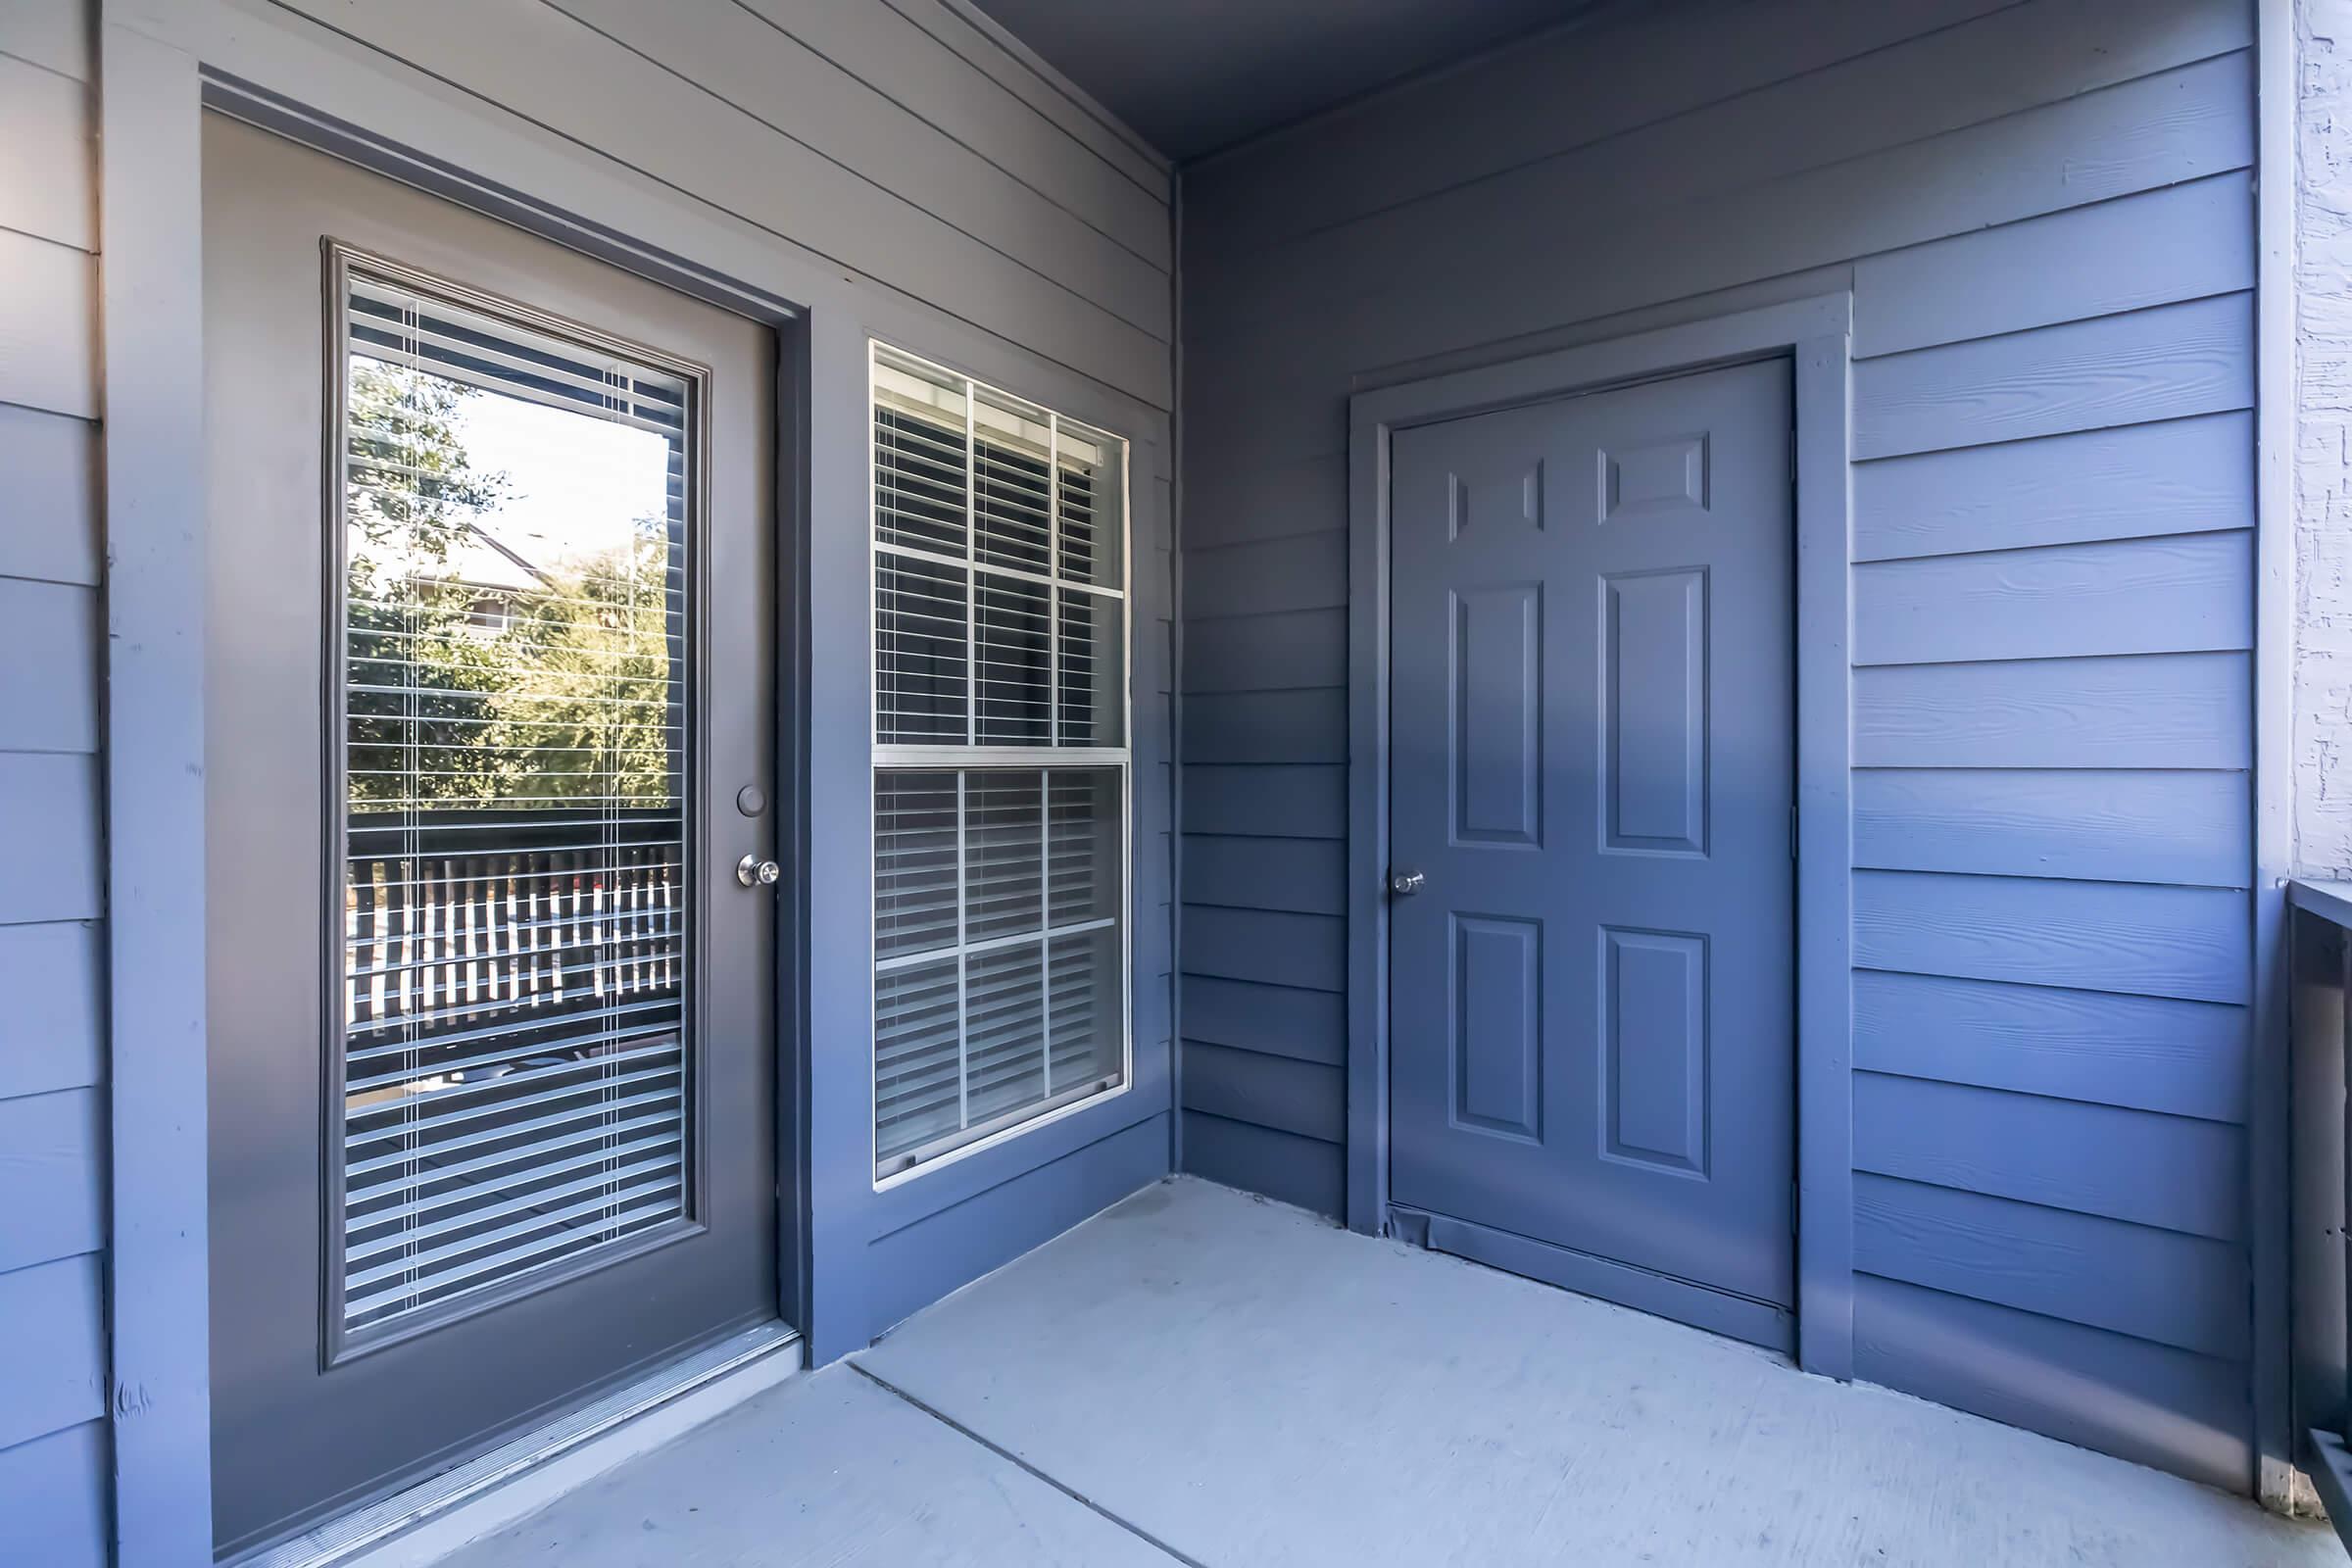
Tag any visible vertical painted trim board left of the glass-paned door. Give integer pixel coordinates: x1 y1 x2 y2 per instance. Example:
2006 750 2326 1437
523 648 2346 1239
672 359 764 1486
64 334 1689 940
99 18 212 1563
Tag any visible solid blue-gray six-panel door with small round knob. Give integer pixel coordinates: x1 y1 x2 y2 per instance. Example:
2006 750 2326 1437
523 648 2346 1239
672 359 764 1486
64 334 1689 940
1390 362 1794 1335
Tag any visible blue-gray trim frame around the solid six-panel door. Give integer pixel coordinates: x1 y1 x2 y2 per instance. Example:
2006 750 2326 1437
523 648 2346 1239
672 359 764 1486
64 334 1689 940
1348 289 1853 1378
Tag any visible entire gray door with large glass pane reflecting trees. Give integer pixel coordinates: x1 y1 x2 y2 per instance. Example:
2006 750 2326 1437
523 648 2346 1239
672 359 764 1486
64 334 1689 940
205 118 778 1554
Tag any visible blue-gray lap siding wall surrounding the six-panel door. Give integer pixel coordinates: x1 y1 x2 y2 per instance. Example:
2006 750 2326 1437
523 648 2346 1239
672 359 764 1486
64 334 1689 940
1181 0 2253 1491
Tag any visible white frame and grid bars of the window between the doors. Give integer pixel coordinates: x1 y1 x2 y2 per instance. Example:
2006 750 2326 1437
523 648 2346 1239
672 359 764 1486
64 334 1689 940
863 338 1136 1192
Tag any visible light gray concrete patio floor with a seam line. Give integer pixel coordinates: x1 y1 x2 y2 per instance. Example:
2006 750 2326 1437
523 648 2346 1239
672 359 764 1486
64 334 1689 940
447 1178 2345 1568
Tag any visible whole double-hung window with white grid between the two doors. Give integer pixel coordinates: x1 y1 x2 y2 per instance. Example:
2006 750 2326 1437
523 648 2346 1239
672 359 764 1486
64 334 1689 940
872 346 1129 1180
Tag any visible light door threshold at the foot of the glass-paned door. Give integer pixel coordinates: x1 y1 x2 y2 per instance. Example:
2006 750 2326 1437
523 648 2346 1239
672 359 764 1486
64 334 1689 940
230 1321 802 1568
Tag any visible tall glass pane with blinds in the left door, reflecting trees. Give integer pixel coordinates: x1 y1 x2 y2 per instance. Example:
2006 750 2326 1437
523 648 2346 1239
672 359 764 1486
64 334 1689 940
334 277 692 1333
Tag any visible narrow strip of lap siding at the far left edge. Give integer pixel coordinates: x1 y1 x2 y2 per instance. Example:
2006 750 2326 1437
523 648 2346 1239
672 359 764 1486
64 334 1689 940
0 0 111 1566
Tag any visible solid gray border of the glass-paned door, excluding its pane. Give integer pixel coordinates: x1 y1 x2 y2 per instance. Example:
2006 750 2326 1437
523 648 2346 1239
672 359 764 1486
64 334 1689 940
205 118 802 1551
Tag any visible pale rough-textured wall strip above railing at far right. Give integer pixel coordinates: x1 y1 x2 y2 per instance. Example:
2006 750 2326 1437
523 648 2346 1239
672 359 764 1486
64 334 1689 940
2295 0 2352 882
